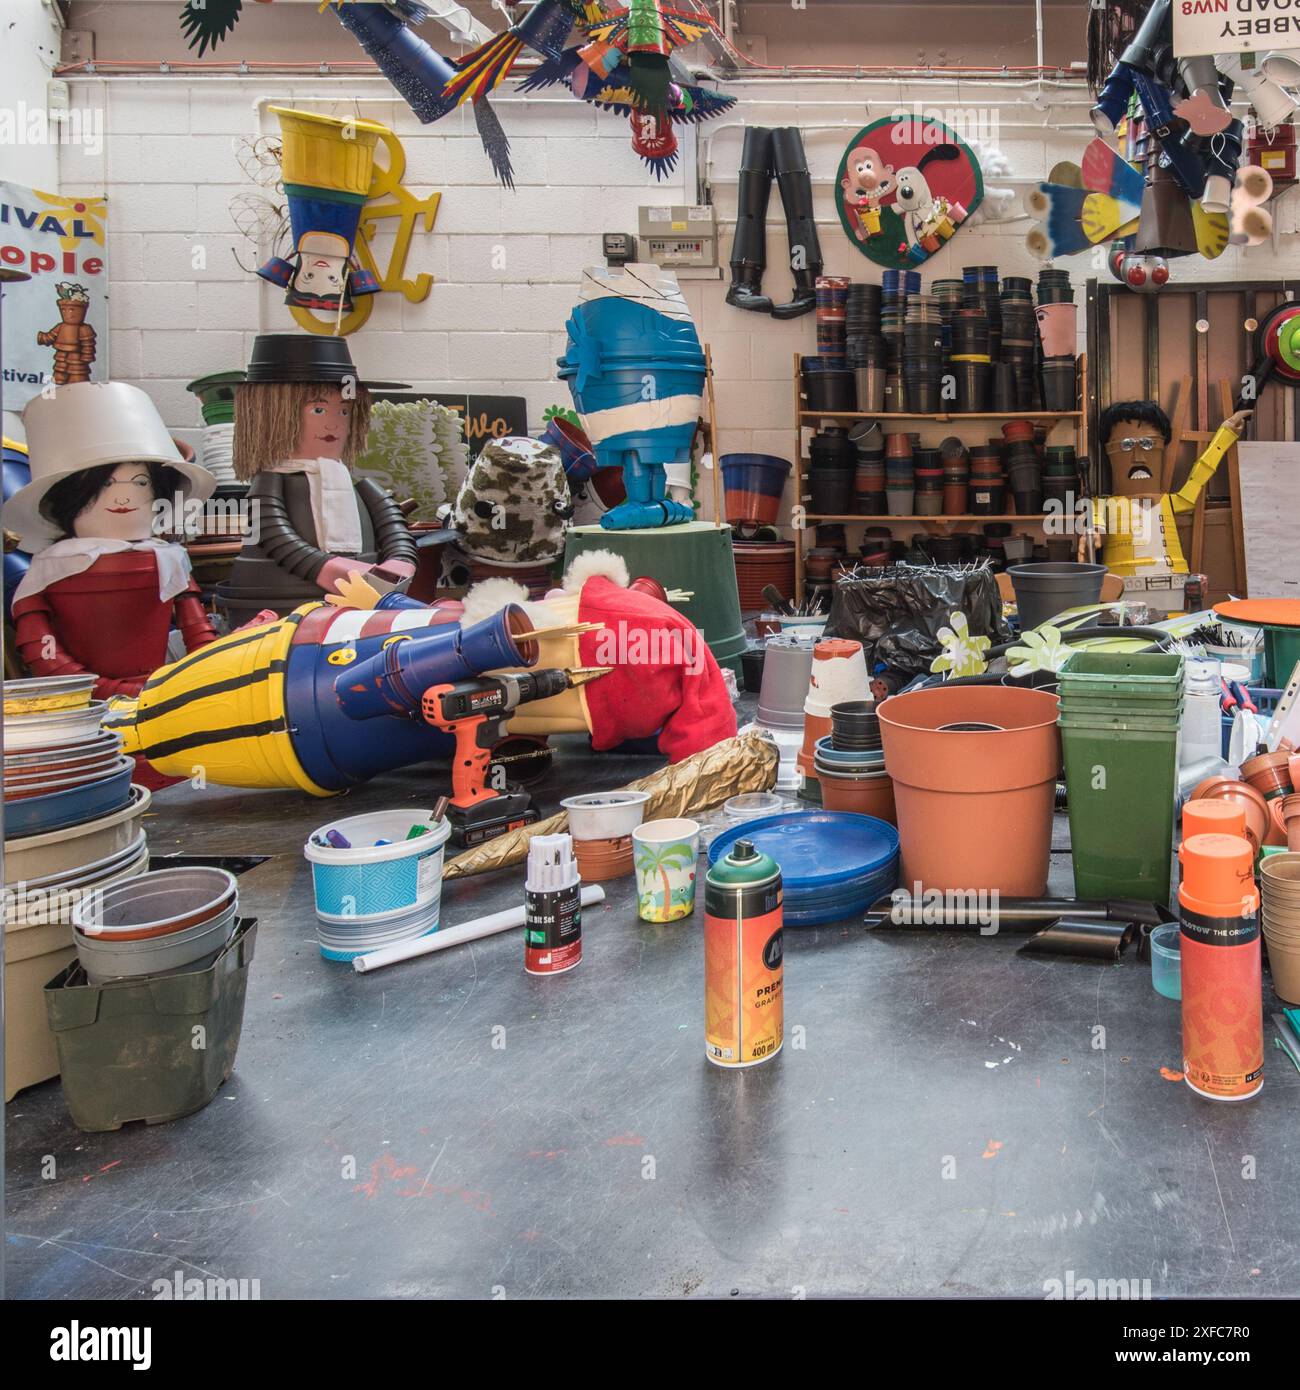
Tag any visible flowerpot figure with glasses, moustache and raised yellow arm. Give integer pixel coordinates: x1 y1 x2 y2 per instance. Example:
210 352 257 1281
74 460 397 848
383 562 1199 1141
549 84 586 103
1091 400 1251 612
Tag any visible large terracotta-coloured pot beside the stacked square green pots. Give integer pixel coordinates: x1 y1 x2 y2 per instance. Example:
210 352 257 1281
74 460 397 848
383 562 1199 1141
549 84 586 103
880 685 1061 898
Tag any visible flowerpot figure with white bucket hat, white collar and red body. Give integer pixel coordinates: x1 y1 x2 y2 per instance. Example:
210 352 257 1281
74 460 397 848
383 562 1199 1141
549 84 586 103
4 381 216 699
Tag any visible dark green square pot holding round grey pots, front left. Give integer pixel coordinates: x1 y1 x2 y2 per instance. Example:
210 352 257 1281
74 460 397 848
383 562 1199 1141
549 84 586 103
44 917 257 1131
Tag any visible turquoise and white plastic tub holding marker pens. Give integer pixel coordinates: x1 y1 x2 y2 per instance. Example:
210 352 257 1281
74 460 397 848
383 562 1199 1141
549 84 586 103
303 810 452 960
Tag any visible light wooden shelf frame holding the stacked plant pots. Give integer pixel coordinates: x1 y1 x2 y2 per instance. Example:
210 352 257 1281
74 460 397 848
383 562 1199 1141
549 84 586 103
793 353 1087 599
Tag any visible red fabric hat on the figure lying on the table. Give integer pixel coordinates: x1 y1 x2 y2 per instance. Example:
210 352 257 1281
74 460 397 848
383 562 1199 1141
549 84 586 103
578 575 736 763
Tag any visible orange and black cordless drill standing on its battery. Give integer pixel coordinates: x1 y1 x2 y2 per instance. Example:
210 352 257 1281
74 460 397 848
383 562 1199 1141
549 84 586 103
420 667 606 847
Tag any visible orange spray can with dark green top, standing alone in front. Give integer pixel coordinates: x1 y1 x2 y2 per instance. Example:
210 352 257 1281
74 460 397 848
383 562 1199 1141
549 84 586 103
704 840 784 1066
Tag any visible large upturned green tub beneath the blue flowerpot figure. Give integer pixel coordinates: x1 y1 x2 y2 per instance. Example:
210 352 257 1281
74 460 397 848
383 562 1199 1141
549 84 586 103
564 521 749 676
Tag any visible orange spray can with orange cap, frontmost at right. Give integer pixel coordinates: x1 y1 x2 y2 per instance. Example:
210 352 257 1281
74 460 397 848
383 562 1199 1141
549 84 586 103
1178 834 1264 1101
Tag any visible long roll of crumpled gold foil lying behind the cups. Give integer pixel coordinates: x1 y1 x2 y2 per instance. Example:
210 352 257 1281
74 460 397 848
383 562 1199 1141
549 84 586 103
442 728 780 878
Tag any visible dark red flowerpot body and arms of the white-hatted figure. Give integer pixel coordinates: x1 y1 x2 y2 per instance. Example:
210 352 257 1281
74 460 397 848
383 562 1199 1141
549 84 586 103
14 550 217 699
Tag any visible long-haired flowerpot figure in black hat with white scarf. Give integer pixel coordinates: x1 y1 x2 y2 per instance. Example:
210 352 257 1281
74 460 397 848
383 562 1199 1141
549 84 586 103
217 334 417 627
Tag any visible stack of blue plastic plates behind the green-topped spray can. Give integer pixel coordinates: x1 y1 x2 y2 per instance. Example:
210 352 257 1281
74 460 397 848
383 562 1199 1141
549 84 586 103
709 810 898 892
